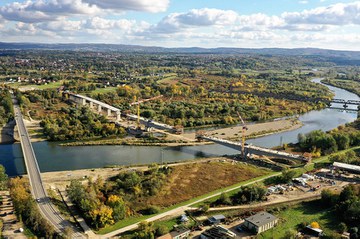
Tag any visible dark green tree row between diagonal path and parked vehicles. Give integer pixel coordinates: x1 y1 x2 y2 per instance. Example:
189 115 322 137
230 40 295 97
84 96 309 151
213 185 267 206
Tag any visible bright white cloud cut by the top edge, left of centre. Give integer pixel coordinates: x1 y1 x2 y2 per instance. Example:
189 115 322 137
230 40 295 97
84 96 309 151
83 0 169 13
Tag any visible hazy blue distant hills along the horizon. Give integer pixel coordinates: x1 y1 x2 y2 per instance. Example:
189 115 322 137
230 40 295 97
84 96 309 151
0 42 360 61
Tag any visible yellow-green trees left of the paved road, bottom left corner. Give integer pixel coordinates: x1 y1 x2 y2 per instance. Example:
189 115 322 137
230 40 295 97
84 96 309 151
9 178 59 238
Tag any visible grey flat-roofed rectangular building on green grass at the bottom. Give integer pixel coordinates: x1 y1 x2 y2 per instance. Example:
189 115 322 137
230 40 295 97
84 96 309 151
244 211 278 233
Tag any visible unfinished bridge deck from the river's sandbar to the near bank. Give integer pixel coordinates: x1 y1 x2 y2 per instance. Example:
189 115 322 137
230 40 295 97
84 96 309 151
197 135 309 162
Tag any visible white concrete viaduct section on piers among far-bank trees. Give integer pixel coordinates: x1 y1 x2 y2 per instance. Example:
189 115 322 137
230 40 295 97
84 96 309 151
67 92 121 121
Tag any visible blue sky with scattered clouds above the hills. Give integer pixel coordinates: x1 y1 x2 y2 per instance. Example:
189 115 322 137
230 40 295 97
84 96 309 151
0 0 360 51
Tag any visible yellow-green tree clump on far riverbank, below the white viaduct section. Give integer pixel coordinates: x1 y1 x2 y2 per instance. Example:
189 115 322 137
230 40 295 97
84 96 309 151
40 107 125 140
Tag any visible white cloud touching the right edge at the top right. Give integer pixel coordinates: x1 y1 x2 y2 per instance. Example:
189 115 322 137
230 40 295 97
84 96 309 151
281 2 360 25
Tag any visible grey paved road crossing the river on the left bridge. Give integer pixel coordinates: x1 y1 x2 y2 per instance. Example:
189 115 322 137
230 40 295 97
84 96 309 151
14 100 84 238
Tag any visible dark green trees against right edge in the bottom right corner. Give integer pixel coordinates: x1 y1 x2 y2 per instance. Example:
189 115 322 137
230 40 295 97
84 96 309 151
321 184 360 239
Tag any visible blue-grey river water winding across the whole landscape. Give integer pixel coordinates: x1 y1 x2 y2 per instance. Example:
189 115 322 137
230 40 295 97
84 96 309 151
0 79 360 176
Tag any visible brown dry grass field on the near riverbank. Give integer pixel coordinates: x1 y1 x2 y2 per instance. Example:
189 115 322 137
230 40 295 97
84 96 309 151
147 162 270 207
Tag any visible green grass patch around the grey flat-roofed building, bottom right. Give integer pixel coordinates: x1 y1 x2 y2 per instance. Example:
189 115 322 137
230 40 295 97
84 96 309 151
259 200 340 239
